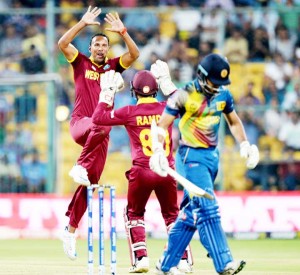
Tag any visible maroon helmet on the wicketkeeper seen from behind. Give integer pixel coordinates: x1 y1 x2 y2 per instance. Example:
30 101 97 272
131 70 158 96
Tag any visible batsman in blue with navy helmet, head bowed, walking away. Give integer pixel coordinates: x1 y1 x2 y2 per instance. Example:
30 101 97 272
150 54 259 275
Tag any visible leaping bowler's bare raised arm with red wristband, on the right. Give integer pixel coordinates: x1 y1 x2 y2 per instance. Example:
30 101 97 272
104 13 140 68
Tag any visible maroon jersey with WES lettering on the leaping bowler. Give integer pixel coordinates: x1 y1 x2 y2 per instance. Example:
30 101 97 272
69 52 126 124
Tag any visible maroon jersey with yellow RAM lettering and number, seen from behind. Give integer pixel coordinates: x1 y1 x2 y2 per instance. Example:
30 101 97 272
93 97 174 167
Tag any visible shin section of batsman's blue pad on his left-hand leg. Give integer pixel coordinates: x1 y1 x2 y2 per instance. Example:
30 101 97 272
161 220 196 272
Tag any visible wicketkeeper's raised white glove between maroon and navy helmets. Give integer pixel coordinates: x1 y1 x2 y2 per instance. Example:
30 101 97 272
150 60 177 96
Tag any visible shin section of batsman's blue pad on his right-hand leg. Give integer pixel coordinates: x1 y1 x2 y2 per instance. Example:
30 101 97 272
197 217 233 272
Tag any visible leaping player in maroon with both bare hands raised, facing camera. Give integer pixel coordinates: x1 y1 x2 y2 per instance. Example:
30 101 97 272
58 7 139 260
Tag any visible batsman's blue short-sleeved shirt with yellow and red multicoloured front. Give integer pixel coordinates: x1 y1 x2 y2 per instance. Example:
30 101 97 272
165 79 234 148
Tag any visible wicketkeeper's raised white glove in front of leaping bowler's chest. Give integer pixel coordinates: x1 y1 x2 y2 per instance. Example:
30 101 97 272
99 70 124 106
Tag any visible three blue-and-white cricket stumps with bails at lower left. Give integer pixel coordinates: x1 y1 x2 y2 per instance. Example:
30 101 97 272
87 184 117 275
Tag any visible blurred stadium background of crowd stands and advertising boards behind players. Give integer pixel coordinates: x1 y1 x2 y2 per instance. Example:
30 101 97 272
0 0 300 238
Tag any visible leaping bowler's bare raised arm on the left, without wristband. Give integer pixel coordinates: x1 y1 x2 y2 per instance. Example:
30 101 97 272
58 6 101 60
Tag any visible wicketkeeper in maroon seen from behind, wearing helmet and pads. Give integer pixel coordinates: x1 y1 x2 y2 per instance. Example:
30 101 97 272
93 70 192 273
